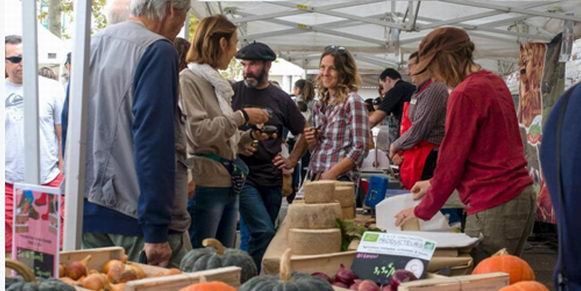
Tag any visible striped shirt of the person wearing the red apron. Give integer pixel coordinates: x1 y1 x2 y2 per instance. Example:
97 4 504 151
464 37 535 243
393 81 448 150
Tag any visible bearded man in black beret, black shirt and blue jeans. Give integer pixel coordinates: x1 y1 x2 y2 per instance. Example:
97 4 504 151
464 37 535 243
232 42 305 269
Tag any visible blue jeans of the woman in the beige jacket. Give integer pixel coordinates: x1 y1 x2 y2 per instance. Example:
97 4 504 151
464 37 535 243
188 186 238 248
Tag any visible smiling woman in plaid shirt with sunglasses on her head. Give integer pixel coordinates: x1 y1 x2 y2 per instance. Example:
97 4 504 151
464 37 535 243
289 46 369 181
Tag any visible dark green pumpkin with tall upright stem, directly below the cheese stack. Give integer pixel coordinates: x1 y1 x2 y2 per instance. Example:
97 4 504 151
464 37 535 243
240 248 333 291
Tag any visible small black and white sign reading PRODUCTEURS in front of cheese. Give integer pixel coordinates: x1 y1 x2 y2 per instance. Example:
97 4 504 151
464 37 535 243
351 232 436 285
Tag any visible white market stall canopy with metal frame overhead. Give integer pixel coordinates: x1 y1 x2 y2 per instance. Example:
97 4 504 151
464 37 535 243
192 0 581 85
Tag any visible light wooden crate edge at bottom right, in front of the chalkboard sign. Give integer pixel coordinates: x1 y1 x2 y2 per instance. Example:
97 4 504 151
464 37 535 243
397 273 510 291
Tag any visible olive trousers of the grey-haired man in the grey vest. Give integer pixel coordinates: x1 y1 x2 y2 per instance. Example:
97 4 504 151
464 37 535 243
82 232 192 268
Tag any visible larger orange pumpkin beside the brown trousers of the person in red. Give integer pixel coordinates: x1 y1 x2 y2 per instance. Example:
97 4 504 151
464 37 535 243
472 249 535 284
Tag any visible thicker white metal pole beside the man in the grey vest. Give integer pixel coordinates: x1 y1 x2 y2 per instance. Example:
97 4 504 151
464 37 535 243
63 0 91 251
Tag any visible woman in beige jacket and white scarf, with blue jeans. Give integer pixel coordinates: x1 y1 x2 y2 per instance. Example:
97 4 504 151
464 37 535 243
176 15 268 248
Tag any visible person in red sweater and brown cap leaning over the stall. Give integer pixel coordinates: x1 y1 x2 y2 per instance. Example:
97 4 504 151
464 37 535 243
395 27 536 263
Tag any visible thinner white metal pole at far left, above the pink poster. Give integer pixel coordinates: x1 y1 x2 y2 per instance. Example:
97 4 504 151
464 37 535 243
22 1 41 184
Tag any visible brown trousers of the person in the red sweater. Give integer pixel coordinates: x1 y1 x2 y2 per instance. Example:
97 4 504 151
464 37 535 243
464 186 536 265
